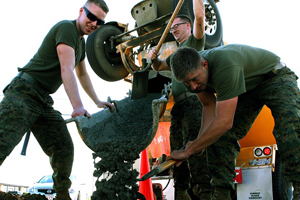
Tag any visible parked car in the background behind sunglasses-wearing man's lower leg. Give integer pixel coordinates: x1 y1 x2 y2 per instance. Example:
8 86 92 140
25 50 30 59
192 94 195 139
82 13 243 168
28 175 80 200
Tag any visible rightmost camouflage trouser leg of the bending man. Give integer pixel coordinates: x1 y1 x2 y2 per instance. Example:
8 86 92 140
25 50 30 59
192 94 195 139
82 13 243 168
258 68 300 183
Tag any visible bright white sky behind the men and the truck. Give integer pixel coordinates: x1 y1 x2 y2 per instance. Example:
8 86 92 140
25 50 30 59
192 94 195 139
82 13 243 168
0 0 300 195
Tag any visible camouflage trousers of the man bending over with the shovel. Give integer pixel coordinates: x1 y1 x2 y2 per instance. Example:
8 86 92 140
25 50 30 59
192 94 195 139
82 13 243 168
207 67 300 189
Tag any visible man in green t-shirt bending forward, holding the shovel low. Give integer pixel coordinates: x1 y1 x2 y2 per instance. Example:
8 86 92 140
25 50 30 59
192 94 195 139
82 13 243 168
169 44 300 200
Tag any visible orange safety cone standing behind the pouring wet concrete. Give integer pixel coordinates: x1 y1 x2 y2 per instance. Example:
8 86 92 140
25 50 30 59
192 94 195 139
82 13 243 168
139 149 154 200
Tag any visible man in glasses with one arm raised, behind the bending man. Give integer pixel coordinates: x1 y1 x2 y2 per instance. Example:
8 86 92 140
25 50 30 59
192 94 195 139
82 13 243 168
149 0 212 200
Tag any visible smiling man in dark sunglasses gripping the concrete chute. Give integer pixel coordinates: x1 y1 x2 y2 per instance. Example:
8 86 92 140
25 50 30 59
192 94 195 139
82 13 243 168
0 0 114 200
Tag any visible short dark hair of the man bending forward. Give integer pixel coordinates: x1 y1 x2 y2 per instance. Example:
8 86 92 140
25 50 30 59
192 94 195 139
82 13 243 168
170 47 201 82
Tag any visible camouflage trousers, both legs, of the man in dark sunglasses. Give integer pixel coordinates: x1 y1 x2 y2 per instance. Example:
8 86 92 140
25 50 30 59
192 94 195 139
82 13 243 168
0 77 74 191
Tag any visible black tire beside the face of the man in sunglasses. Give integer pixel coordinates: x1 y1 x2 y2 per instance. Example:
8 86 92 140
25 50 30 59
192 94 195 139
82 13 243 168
86 25 129 82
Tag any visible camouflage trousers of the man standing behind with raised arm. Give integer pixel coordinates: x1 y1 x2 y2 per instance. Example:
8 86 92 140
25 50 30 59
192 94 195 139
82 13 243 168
170 95 211 190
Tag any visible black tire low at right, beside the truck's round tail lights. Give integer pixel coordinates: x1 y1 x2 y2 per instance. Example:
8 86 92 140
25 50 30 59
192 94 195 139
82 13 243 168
272 153 292 200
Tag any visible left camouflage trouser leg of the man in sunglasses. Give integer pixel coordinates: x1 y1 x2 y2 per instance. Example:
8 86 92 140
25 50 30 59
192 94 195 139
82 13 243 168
0 78 43 165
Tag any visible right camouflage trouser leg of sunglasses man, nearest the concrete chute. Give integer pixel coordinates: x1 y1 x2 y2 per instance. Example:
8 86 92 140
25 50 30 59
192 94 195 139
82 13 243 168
31 99 74 192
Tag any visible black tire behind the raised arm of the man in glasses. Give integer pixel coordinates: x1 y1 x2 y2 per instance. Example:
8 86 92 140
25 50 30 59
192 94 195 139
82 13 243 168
173 0 223 49
